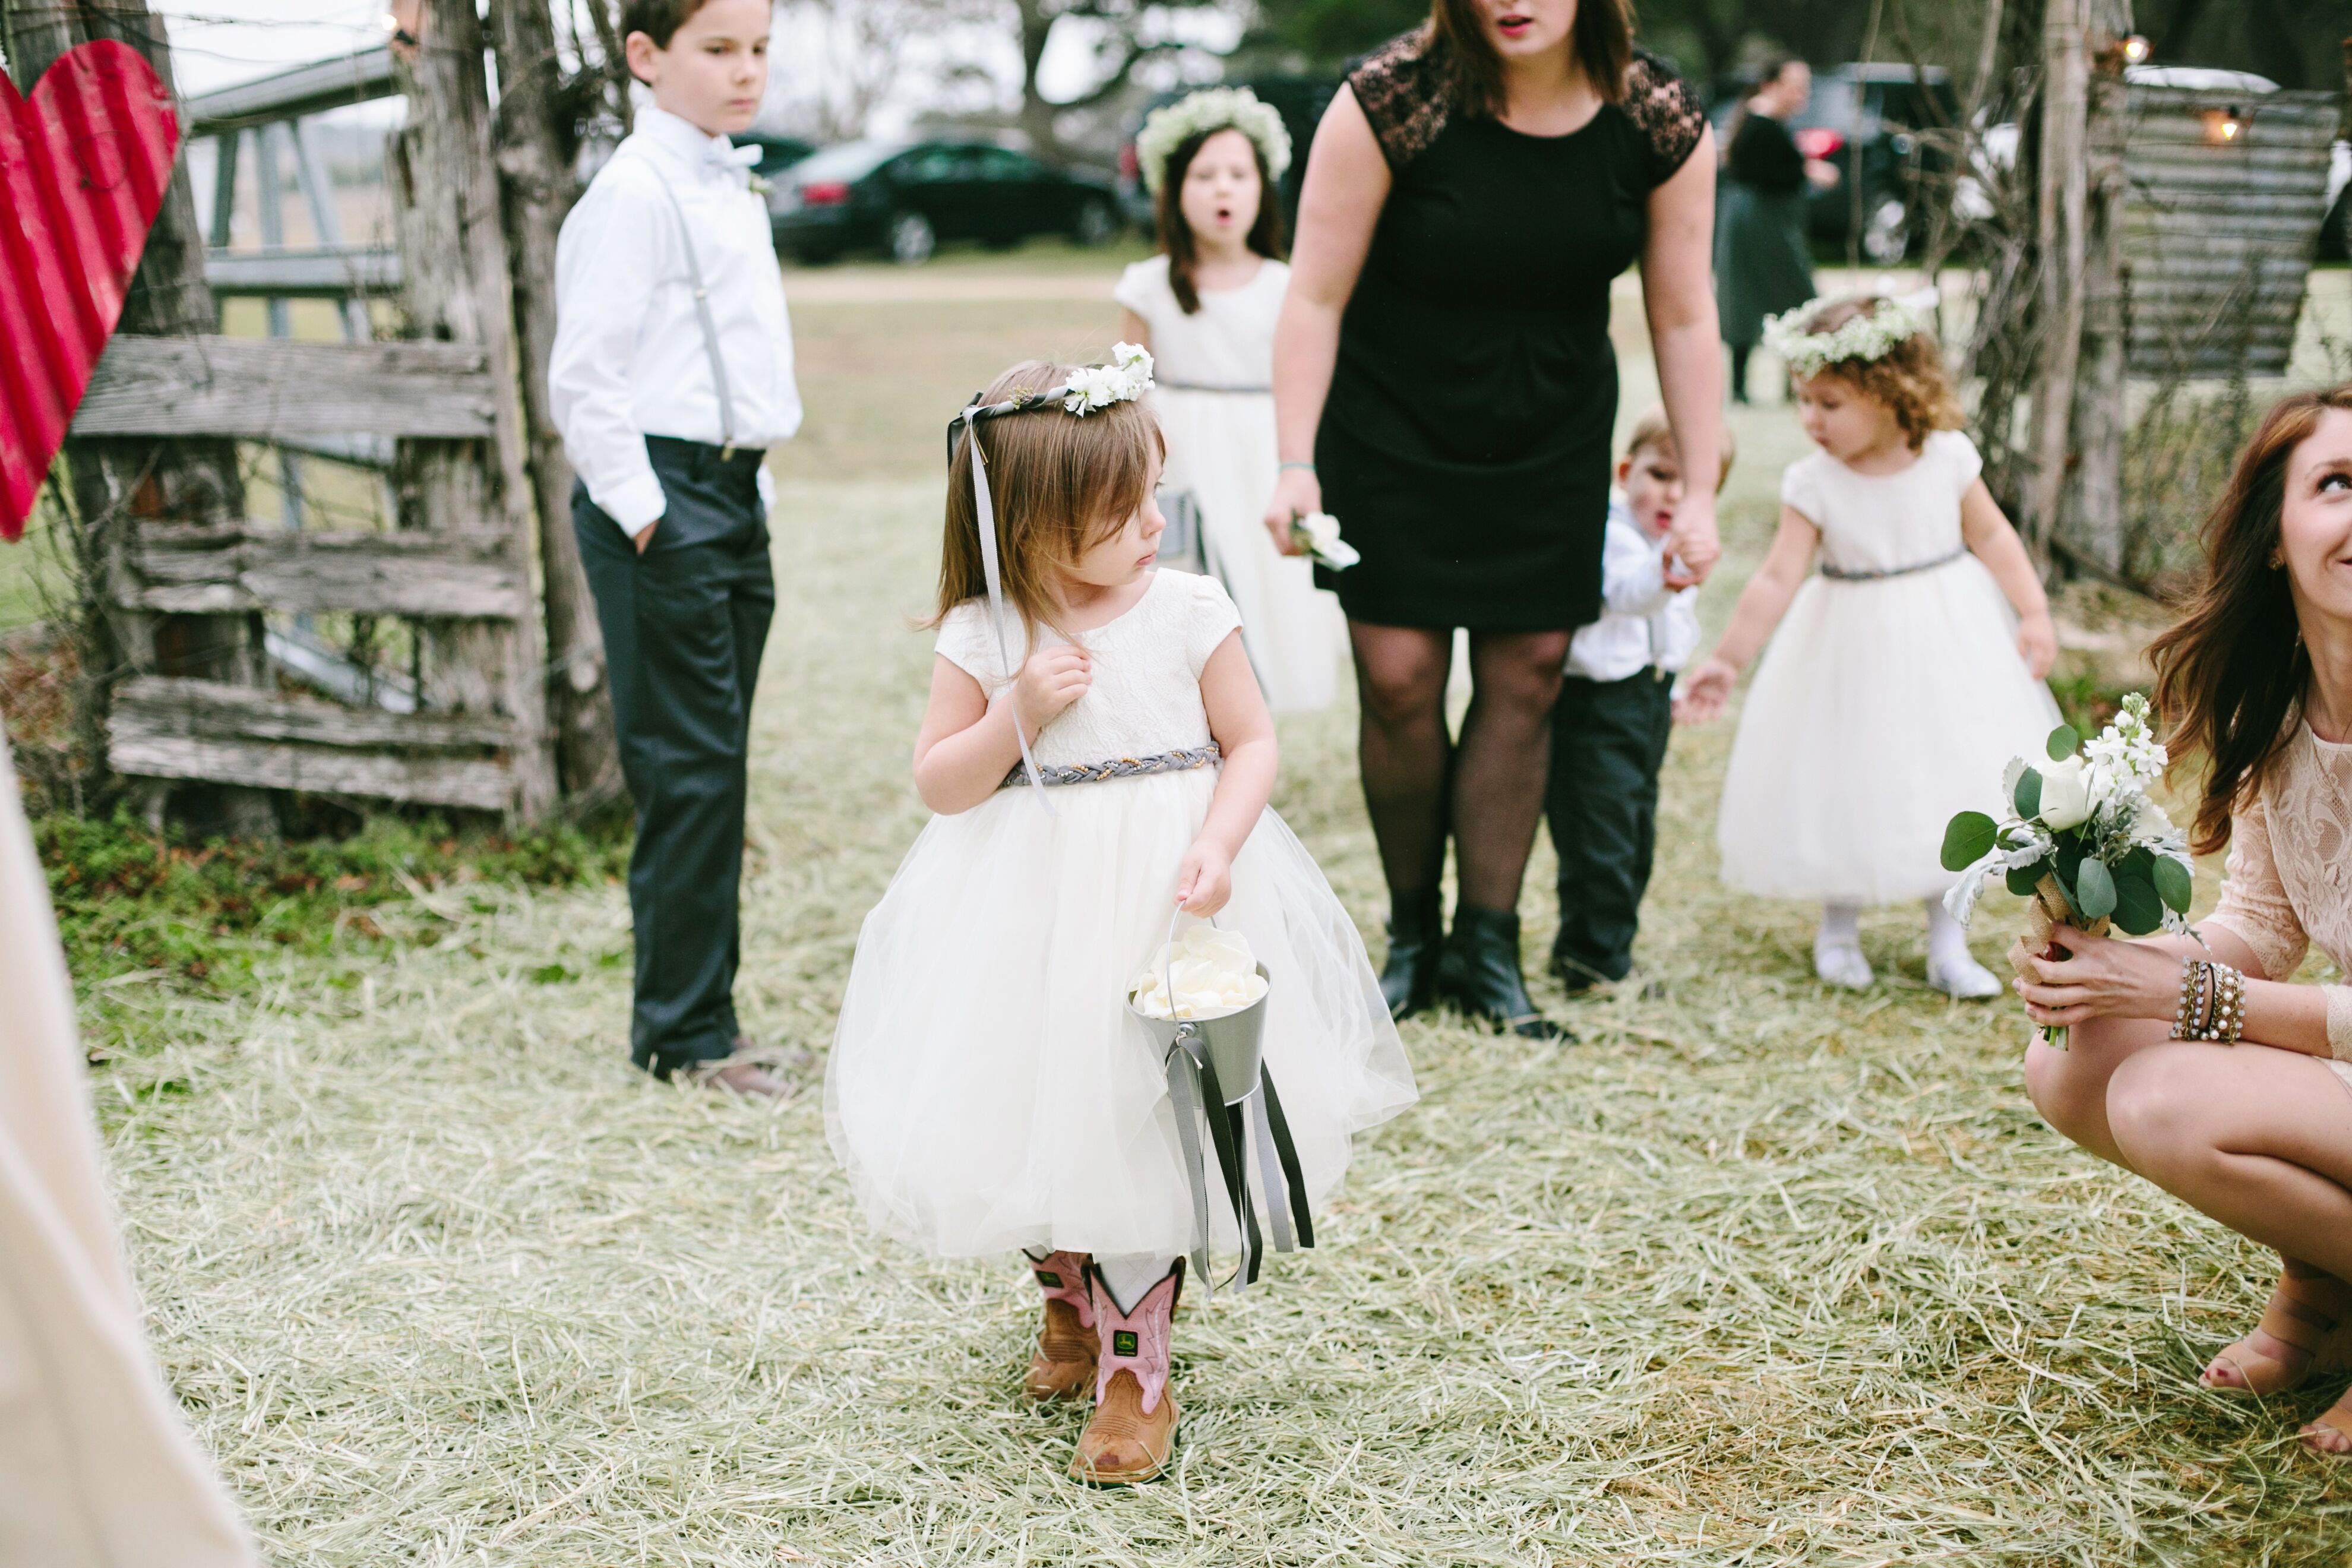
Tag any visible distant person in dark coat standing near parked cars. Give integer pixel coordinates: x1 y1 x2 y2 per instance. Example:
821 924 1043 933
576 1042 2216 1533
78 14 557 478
1715 59 1837 402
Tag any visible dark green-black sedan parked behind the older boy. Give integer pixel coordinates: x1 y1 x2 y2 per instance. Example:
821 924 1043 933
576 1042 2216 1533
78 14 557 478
769 141 1120 265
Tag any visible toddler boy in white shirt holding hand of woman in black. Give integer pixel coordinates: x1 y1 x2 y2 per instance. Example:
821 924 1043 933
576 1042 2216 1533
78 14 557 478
1543 407 1731 994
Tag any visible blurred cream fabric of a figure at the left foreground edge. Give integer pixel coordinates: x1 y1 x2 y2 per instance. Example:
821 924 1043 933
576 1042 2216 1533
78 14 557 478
0 741 257 1568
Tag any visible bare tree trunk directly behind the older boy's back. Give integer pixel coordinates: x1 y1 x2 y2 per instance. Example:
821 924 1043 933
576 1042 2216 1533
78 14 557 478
489 0 623 811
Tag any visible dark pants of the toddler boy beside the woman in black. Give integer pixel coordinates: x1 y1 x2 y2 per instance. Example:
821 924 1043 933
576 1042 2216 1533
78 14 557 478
1543 670 1675 980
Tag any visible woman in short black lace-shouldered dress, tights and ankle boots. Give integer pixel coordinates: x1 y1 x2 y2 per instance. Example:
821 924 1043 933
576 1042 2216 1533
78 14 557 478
1265 0 1722 1039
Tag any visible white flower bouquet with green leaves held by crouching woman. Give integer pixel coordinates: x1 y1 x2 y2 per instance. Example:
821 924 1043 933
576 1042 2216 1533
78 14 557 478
1943 691 2195 1048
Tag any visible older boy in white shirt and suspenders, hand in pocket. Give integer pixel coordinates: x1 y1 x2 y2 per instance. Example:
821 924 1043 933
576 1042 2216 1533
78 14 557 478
548 0 799 1095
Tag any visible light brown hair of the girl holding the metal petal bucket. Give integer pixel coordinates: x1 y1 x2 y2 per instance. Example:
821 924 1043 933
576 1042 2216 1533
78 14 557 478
927 360 1166 644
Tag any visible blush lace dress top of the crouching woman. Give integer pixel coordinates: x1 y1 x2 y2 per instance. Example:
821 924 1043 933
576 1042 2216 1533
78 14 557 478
2206 724 2352 1089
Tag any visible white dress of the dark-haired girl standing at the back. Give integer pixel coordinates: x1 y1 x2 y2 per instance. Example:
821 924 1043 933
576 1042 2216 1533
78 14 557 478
1112 256 1348 712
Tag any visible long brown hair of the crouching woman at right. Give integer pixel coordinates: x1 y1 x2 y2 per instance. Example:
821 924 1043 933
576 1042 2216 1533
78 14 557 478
2147 383 2352 856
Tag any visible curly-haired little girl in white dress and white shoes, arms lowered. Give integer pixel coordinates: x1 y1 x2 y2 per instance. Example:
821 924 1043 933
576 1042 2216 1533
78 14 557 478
1675 299 2058 997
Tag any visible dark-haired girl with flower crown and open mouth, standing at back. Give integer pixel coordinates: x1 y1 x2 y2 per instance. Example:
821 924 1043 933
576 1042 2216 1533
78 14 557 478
1112 87 1343 712
